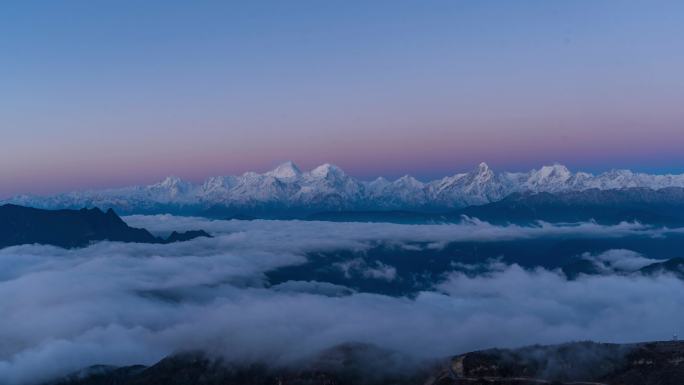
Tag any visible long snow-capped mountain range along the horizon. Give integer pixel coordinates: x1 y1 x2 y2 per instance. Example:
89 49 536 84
3 162 684 214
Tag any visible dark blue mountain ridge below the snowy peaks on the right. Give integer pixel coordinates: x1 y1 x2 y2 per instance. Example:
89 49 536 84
314 187 684 226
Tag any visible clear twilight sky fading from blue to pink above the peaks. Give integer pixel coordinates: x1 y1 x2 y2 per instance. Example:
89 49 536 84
0 0 684 196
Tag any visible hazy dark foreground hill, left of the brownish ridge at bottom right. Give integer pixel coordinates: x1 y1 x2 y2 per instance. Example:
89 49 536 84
50 344 430 385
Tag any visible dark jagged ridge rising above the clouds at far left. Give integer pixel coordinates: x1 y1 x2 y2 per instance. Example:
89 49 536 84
0 205 209 248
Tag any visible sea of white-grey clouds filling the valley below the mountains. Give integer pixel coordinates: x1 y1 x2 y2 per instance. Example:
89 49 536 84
0 216 684 385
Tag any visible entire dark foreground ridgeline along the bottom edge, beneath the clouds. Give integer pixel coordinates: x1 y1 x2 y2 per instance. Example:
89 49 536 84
49 342 684 385
